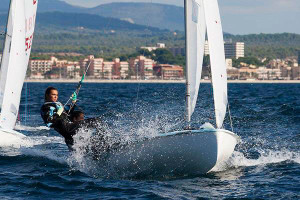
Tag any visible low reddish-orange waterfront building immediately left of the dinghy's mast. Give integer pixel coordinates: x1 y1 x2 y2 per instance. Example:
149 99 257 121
153 64 184 80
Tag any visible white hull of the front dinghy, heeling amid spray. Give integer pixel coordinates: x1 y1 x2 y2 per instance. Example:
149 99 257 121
106 129 239 175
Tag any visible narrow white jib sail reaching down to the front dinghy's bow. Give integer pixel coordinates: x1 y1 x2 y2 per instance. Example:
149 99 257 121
204 0 227 128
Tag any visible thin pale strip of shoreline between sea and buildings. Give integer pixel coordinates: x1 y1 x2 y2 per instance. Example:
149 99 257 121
25 79 300 84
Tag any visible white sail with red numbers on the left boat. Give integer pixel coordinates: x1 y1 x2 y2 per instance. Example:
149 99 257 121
0 0 38 129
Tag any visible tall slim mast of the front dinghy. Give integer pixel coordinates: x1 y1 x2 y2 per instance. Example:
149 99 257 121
184 0 191 123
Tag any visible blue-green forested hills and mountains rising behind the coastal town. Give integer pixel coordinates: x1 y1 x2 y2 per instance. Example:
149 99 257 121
0 0 300 58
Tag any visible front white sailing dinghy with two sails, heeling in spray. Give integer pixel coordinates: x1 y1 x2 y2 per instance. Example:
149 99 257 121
99 0 239 175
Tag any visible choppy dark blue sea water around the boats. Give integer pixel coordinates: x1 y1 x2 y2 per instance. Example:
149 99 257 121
0 83 300 199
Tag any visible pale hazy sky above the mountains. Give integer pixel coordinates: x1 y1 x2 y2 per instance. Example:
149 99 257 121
65 0 300 34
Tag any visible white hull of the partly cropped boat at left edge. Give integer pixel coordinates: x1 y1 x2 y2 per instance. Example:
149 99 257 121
0 128 26 147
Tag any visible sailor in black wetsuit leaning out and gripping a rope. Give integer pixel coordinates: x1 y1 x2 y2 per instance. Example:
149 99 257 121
41 87 81 150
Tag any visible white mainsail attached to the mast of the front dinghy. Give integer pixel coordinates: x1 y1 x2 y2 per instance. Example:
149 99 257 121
185 0 206 121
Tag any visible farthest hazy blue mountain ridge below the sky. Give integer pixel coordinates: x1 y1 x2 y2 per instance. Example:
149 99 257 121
0 0 184 31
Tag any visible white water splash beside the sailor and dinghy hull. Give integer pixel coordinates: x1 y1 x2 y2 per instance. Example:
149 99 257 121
69 111 186 178
